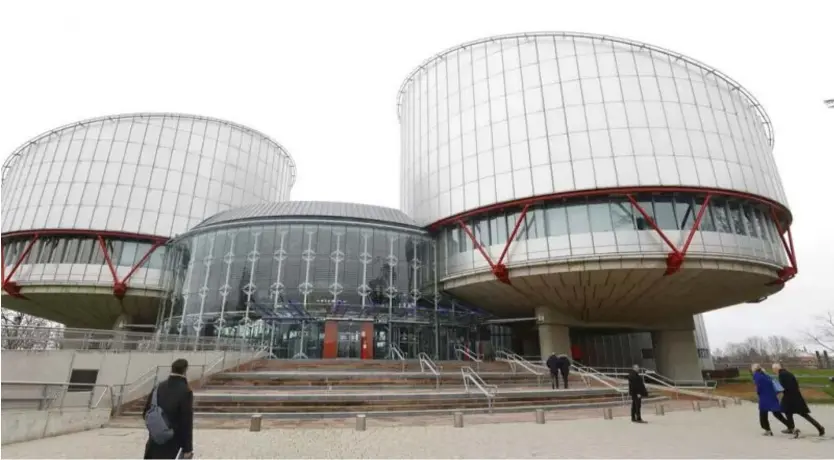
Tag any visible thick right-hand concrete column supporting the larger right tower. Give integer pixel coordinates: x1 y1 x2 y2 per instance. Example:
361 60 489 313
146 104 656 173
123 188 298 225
652 329 703 381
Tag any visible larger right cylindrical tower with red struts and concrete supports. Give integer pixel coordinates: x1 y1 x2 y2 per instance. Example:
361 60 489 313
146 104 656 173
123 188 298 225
398 33 796 375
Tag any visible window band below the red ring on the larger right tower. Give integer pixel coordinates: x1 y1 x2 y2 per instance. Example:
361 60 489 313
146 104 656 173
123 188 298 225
437 193 787 279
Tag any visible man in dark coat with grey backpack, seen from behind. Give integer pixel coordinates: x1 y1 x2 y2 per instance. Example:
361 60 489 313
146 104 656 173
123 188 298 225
142 359 194 458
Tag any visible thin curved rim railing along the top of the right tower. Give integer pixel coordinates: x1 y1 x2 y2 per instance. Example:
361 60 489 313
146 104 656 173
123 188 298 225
397 32 774 147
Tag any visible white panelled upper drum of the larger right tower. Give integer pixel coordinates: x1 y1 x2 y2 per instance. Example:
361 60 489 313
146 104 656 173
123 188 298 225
399 34 787 225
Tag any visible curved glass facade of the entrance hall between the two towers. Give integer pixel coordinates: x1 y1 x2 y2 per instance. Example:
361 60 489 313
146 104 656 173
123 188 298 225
159 221 487 358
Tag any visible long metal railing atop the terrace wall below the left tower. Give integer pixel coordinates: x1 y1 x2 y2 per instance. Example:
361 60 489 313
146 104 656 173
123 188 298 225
2 326 262 352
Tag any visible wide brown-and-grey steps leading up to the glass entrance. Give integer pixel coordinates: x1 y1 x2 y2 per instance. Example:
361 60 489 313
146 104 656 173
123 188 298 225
118 360 623 419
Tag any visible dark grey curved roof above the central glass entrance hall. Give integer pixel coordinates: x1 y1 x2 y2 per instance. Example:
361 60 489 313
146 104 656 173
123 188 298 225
188 201 424 236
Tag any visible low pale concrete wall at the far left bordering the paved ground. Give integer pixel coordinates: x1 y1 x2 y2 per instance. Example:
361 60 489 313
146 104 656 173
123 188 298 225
2 407 110 445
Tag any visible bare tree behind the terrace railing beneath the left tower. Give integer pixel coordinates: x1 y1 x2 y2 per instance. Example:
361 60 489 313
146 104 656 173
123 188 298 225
2 308 61 350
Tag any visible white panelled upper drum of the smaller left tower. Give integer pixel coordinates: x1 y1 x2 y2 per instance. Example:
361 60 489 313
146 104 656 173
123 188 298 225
2 114 295 237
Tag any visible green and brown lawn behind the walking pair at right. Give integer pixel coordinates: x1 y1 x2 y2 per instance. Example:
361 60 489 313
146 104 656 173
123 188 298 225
715 369 834 404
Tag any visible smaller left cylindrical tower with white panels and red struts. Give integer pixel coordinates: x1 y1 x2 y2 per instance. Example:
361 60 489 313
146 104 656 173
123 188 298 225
2 113 295 328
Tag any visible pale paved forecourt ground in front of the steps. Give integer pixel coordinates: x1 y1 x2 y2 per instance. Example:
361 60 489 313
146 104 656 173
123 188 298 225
2 404 834 458
